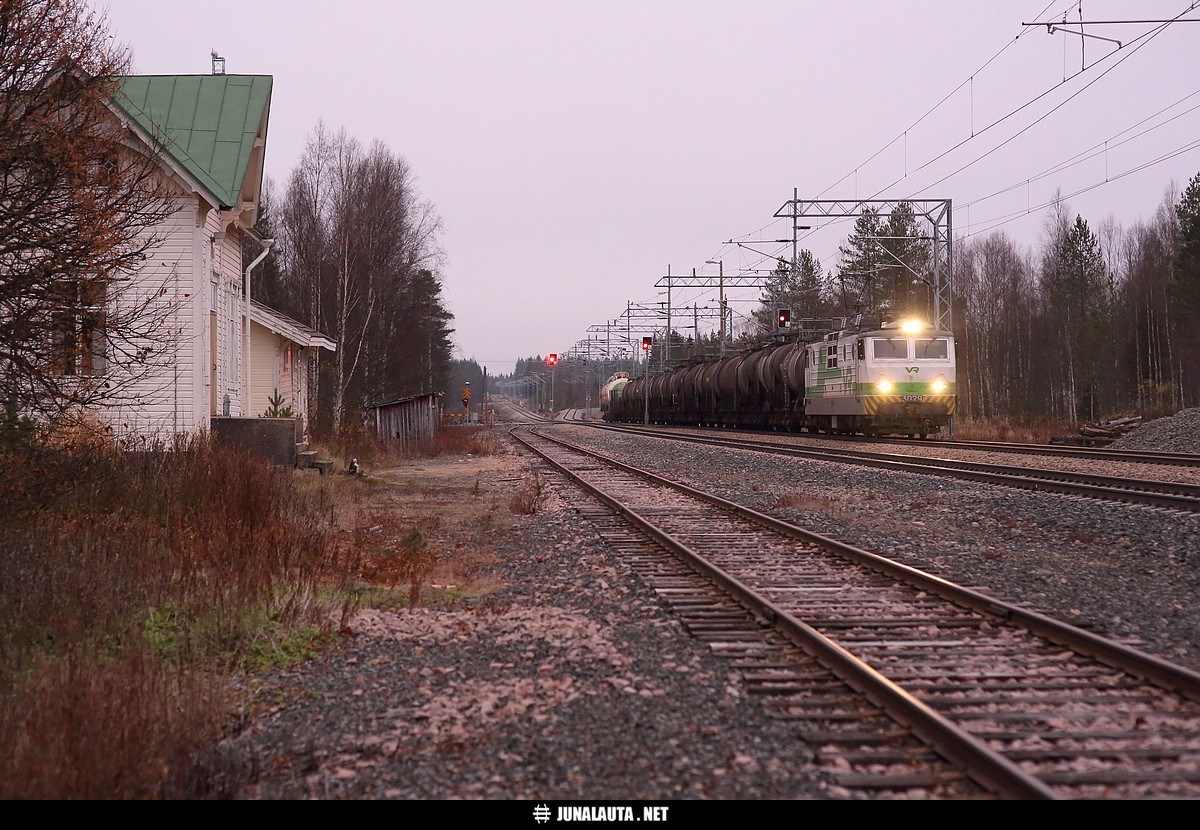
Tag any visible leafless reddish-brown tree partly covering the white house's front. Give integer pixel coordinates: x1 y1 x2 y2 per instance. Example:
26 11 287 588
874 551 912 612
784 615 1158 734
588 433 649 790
0 0 173 426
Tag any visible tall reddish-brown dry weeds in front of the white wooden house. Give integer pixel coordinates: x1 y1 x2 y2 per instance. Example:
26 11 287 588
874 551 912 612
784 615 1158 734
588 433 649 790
0 440 353 799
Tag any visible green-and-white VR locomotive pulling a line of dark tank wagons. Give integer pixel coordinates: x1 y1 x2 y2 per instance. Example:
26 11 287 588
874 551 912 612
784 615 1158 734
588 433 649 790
600 314 955 438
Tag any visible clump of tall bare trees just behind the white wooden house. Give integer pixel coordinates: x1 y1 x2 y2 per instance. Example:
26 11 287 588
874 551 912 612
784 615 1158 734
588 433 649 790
280 125 451 431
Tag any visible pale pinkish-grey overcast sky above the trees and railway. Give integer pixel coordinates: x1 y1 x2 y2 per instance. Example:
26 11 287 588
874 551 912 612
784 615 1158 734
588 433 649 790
95 0 1200 375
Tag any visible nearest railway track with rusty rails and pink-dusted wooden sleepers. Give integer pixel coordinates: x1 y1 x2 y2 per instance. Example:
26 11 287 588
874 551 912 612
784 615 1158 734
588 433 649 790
514 428 1200 799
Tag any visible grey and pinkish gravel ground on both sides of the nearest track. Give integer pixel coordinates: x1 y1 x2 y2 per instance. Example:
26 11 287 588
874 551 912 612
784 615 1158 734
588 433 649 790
223 422 1200 800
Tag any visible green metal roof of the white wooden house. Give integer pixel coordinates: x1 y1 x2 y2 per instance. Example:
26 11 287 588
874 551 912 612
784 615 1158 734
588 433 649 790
116 74 271 208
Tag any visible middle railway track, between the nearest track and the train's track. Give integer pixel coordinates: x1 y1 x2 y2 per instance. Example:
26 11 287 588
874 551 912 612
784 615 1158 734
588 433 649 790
573 423 1200 512
